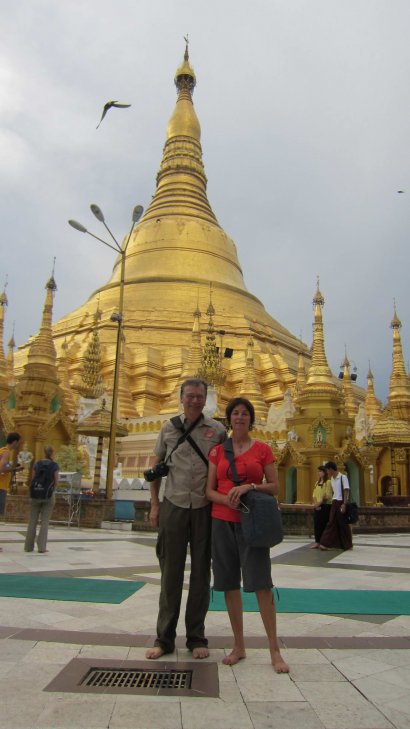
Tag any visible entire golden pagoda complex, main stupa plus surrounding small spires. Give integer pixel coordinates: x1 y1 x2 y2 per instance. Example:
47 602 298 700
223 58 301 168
4 48 410 506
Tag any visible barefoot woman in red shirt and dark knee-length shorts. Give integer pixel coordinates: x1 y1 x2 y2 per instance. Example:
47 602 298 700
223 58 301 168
206 397 289 673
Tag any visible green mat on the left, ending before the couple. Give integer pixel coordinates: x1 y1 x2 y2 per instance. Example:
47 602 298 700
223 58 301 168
0 574 145 604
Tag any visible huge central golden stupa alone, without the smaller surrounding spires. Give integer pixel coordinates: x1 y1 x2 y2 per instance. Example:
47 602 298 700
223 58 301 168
16 49 309 418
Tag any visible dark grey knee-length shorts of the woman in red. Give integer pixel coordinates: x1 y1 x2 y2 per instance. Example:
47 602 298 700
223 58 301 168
212 519 273 592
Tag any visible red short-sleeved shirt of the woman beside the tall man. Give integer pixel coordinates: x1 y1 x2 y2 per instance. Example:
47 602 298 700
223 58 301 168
209 440 276 522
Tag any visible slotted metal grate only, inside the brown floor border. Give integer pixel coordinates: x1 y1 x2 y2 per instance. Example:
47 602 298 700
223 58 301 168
84 668 192 690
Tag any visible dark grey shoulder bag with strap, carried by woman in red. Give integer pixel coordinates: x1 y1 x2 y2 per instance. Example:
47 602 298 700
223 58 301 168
224 438 283 548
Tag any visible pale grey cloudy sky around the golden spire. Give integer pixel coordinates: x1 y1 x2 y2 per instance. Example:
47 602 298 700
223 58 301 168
0 0 410 399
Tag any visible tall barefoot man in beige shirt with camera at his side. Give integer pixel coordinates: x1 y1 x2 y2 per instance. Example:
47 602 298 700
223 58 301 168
146 379 226 659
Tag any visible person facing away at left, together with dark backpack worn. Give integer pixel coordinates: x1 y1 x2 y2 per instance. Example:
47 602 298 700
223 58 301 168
24 446 58 554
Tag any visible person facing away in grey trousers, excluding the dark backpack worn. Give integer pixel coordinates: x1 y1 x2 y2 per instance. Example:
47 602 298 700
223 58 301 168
24 446 58 554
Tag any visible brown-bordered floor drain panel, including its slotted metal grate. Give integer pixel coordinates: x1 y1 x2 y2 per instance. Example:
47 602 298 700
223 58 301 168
44 658 219 697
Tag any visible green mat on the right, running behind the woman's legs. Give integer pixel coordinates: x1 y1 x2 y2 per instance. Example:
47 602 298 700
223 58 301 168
209 587 410 615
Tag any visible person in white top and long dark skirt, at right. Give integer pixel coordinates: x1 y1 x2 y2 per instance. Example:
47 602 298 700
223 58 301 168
319 461 353 551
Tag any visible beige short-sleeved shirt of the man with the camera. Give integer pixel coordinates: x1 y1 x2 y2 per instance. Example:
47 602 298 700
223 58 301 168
154 415 226 509
